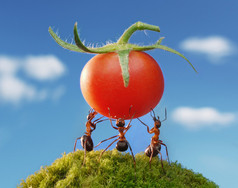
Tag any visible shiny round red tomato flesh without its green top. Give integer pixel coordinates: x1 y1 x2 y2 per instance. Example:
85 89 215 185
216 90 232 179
80 51 164 119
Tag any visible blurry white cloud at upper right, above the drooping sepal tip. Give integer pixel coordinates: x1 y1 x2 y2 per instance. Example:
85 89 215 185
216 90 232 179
181 36 235 61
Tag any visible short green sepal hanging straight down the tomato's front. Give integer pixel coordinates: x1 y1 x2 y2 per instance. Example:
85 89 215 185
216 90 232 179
117 49 131 87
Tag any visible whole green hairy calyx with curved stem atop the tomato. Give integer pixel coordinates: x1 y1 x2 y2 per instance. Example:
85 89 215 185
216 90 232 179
49 22 197 87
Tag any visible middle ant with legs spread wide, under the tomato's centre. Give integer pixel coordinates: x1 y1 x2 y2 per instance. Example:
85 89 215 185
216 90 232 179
95 108 136 169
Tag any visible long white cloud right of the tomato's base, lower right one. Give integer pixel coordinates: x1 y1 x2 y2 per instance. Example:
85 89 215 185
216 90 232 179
172 107 236 129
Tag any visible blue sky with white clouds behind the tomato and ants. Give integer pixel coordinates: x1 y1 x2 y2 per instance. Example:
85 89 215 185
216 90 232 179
0 0 238 187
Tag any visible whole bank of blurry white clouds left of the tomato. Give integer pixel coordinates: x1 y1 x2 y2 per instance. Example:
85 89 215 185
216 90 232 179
0 55 66 104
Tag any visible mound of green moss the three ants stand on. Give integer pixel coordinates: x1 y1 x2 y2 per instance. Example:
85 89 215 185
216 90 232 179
18 149 218 188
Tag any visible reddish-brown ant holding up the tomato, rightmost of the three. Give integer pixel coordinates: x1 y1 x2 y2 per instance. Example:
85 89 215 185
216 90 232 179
137 108 170 168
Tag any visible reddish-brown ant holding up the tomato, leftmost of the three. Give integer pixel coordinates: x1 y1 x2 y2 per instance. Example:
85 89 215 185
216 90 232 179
74 108 108 165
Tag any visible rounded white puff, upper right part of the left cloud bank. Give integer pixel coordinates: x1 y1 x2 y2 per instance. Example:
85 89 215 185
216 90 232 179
24 55 65 80
